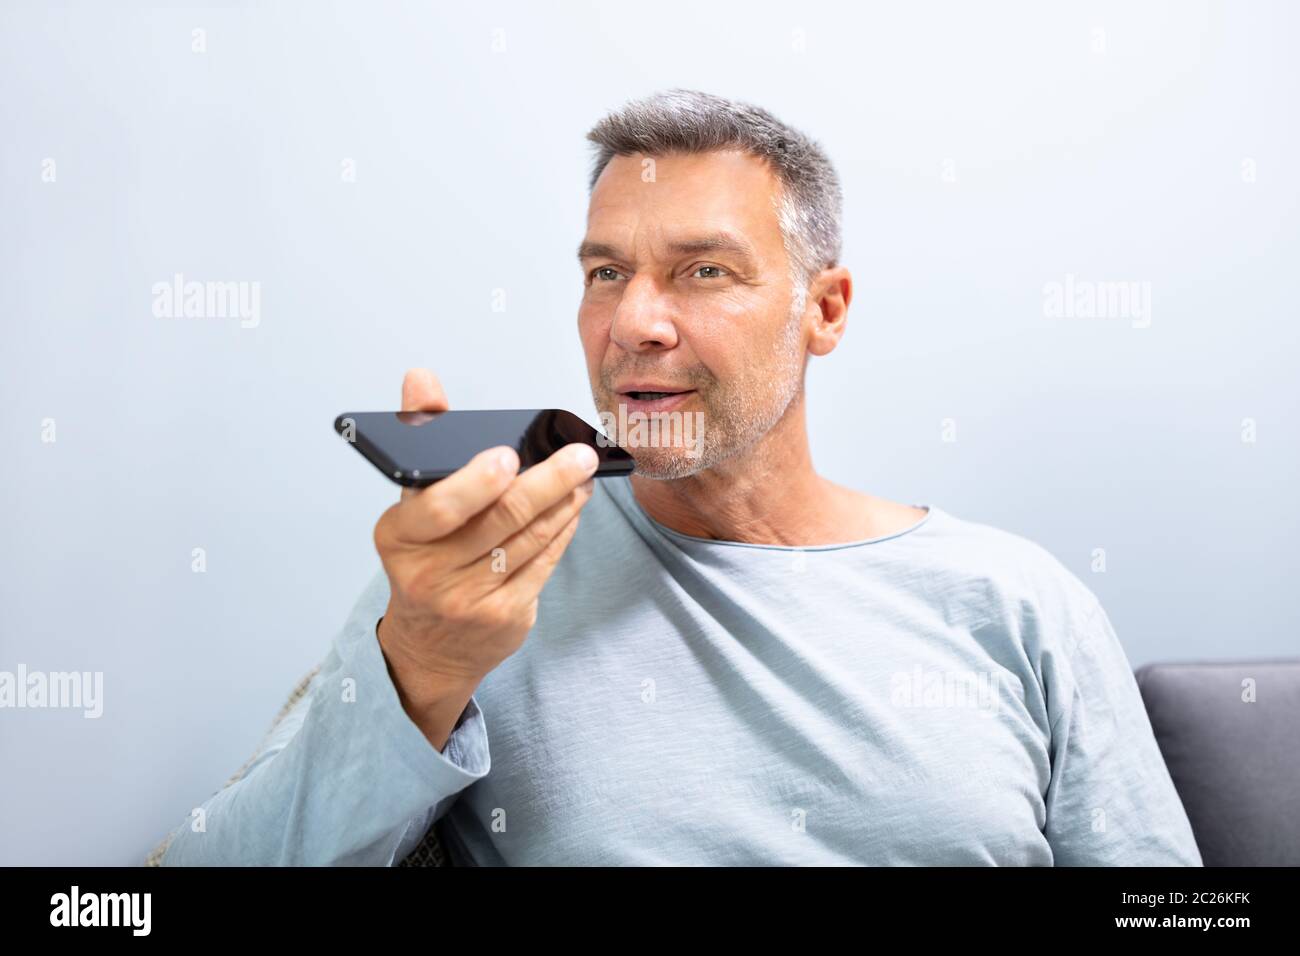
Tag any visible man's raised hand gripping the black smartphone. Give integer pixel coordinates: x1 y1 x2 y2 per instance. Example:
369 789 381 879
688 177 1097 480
374 368 597 752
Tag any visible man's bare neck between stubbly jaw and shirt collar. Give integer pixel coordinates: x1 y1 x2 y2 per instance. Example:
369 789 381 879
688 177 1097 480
632 392 847 546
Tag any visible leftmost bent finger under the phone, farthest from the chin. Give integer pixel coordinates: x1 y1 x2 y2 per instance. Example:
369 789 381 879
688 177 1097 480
391 445 519 541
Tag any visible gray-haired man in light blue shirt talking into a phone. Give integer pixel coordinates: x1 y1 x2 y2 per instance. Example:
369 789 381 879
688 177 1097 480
164 90 1201 865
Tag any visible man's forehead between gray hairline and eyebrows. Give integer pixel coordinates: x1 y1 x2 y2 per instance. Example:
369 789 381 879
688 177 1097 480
586 150 784 254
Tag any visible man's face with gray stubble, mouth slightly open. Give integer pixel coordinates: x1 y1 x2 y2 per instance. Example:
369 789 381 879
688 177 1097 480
579 151 806 479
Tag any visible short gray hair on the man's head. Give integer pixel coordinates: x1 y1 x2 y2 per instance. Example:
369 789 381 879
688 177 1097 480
586 88 844 311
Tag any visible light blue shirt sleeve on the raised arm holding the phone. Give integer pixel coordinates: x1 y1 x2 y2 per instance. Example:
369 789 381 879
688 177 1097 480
161 572 491 866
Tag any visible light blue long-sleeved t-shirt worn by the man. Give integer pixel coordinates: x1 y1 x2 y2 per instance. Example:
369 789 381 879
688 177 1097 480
164 477 1201 865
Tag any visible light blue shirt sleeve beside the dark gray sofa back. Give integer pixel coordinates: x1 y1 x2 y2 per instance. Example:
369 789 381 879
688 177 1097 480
1043 592 1203 866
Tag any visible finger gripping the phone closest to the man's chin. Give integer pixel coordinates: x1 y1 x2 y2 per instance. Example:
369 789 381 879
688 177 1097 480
449 442 599 566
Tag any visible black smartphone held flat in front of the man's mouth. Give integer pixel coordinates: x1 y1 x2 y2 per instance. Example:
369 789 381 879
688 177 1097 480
334 408 636 488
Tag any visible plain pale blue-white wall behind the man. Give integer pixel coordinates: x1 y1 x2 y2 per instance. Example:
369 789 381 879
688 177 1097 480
0 0 1300 864
